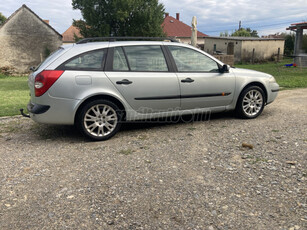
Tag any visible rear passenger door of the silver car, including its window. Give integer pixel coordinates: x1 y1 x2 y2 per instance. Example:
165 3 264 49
105 45 180 113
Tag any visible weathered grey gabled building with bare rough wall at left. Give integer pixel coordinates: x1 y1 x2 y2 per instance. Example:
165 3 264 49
0 5 62 73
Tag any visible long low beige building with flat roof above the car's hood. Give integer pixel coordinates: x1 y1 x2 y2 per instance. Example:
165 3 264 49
204 37 285 63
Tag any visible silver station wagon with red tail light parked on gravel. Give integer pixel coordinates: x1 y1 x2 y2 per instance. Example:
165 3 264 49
22 38 279 140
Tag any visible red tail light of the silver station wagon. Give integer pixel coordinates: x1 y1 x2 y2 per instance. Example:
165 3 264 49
34 70 64 97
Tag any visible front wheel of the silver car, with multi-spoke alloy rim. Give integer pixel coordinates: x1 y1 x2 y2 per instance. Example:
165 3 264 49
236 86 266 119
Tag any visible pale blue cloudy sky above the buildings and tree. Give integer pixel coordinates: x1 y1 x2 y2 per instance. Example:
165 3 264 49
0 0 307 36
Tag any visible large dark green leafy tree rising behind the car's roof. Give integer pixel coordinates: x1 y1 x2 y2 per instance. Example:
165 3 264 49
72 0 164 37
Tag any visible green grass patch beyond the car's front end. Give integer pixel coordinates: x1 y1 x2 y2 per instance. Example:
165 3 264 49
235 58 307 89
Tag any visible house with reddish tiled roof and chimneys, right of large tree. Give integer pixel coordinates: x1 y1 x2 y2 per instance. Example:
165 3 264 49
162 13 208 48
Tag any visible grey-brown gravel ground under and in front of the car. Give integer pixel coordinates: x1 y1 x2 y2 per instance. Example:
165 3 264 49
0 89 307 230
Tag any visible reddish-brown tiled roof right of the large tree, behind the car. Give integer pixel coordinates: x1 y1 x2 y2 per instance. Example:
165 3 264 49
162 16 208 37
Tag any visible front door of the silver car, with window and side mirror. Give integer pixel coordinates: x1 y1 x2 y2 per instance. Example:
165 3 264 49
168 45 235 110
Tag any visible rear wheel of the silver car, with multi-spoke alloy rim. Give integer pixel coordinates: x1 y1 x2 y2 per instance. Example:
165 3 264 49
76 99 123 141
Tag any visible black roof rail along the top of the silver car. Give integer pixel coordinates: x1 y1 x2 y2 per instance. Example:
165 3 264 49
76 37 179 44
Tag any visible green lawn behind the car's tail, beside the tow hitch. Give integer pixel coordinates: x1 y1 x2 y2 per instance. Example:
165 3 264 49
0 74 30 117
